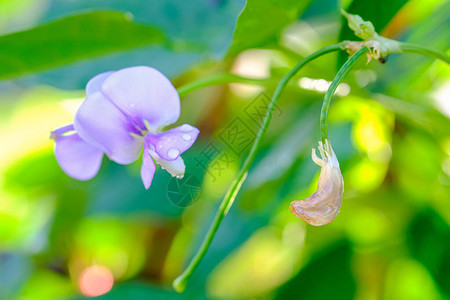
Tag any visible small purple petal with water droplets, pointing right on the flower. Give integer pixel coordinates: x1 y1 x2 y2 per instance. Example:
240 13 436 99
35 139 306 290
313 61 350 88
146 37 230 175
146 124 200 161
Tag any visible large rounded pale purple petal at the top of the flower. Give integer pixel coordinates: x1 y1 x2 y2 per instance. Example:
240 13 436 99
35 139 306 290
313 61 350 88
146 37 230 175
102 66 180 131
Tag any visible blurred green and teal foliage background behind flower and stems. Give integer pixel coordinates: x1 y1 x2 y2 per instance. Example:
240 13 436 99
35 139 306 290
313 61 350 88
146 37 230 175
0 0 450 300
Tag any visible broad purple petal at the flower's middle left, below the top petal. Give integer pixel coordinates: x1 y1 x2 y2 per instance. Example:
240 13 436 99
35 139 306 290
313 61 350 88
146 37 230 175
74 93 143 164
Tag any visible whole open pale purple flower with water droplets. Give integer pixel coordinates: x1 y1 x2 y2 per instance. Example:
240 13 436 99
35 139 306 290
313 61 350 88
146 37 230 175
51 66 199 189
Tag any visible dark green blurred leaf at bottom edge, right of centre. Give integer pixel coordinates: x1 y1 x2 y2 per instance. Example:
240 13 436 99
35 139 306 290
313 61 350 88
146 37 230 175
275 242 356 299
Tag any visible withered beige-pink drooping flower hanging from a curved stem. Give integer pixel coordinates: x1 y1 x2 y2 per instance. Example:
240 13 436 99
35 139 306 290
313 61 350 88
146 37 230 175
289 140 344 226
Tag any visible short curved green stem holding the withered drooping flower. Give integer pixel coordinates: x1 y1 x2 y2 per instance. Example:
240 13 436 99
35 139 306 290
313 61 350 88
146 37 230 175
320 47 369 145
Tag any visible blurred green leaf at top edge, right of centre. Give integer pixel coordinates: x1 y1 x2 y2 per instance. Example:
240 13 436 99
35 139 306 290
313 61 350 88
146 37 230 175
228 0 311 55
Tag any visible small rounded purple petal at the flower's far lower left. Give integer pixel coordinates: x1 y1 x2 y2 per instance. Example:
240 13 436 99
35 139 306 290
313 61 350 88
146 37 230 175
55 133 103 180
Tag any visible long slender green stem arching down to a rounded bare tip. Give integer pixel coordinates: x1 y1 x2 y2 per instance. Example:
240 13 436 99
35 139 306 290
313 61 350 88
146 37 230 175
173 43 343 292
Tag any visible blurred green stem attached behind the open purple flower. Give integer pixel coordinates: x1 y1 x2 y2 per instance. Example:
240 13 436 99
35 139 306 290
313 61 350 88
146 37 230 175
177 73 270 97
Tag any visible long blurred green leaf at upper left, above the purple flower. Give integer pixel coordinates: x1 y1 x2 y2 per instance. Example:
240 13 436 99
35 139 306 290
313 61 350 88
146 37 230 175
0 11 165 79
